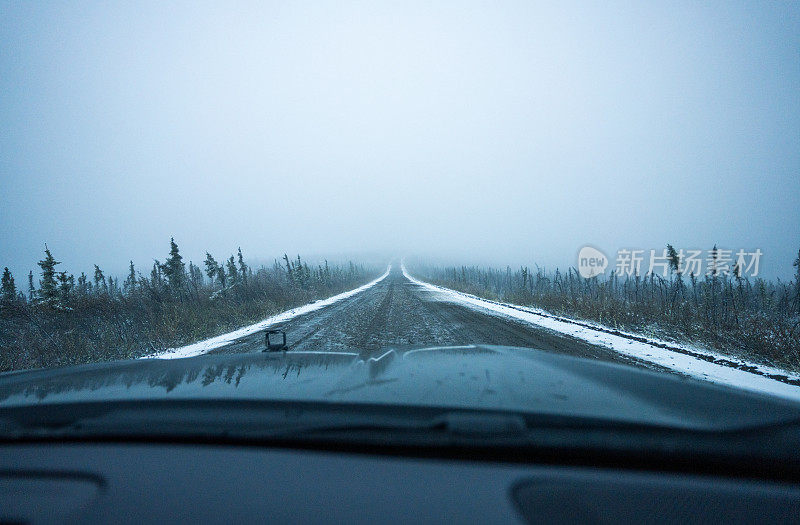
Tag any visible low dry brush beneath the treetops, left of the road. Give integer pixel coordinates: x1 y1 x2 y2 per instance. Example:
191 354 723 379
0 264 378 371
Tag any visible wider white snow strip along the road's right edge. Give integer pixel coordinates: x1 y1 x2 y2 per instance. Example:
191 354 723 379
401 264 800 400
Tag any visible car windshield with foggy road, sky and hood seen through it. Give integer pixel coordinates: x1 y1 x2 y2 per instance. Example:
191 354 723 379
0 1 800 444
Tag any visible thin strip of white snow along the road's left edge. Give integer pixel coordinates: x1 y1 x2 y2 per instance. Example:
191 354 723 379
146 265 392 359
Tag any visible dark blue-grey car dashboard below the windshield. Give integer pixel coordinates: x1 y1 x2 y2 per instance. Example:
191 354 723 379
0 443 800 523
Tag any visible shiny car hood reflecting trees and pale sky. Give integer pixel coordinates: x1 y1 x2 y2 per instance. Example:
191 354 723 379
0 345 800 428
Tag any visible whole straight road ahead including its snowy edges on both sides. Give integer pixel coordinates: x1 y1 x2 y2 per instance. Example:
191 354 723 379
152 265 800 400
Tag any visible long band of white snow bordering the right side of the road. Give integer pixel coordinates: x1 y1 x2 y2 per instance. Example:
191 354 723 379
401 264 800 401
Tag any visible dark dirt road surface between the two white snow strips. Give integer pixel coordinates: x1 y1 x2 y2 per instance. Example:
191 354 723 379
213 265 664 368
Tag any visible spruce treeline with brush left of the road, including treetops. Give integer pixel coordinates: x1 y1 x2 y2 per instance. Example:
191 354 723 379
0 239 378 371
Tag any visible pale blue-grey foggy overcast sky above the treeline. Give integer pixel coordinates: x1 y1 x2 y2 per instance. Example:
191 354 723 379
0 1 800 282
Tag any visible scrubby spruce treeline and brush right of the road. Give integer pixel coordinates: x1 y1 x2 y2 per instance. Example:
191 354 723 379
417 249 800 370
